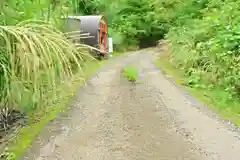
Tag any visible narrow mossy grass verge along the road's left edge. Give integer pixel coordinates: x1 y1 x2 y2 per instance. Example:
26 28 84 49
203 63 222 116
4 59 103 160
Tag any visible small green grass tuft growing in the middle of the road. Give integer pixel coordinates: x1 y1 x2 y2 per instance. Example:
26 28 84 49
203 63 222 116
122 66 137 82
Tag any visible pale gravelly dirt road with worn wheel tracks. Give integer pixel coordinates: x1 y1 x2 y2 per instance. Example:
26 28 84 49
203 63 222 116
23 51 240 160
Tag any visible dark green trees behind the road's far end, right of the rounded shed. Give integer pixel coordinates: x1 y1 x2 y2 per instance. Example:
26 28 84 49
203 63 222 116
75 0 167 49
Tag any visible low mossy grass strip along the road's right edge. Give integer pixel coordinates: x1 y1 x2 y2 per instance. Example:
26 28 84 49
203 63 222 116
154 56 240 126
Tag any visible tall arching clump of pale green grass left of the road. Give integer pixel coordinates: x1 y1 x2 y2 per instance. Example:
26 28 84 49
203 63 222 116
0 21 87 131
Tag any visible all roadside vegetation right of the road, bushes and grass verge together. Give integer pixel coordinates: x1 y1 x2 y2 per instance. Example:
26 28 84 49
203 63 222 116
159 0 240 125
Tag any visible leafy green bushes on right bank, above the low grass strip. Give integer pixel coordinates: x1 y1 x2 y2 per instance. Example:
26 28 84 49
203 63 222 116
167 0 240 99
